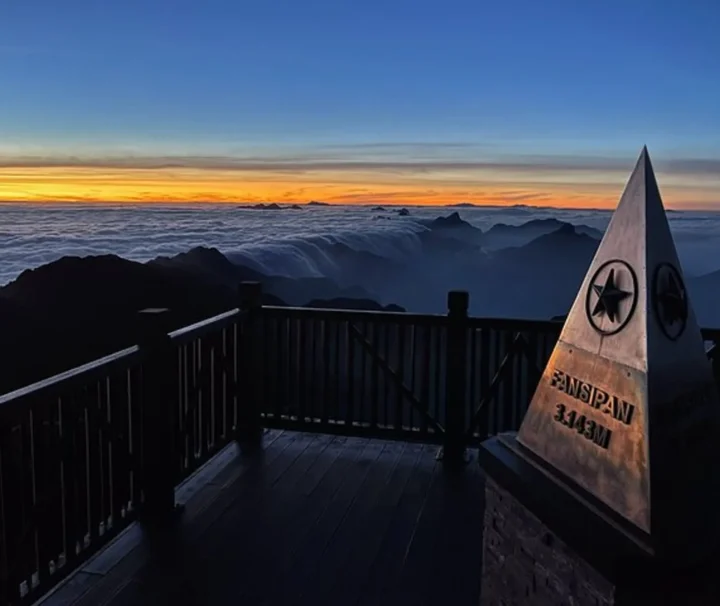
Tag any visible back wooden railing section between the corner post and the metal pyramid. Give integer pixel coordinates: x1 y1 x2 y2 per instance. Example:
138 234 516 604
258 293 562 454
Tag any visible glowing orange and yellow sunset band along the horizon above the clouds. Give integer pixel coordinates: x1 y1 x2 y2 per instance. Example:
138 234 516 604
0 162 720 208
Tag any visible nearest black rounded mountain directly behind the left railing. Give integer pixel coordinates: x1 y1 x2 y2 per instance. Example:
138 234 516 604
0 255 242 392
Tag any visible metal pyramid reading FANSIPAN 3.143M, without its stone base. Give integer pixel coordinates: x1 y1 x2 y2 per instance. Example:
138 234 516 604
517 148 720 550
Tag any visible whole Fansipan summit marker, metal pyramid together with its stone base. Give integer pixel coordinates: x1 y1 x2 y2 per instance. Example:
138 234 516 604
478 148 720 606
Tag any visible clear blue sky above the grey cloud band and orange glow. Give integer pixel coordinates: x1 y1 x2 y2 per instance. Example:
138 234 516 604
0 0 720 207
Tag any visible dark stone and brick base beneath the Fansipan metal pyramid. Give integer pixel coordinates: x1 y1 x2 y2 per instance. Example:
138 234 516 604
479 435 720 606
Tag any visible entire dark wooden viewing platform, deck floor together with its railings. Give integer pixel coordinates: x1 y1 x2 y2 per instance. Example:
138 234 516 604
0 283 720 606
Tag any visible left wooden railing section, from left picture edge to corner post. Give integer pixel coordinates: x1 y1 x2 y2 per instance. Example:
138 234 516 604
0 300 254 605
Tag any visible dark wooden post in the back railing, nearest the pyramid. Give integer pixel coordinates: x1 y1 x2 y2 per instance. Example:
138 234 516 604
441 290 470 466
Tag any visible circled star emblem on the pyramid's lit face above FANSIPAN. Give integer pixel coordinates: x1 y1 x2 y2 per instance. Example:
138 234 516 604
585 259 637 335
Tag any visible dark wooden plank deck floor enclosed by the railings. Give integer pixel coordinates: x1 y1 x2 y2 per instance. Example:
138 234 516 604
42 431 490 606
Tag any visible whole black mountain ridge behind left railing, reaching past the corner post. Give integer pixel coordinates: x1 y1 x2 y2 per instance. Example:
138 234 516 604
0 248 404 393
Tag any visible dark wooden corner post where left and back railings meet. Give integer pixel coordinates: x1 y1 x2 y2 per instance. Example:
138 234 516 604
236 282 264 452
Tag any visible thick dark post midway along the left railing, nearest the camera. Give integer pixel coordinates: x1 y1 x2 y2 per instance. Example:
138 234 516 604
138 309 180 523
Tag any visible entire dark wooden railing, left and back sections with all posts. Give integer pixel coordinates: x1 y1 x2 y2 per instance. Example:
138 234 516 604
0 283 720 605
